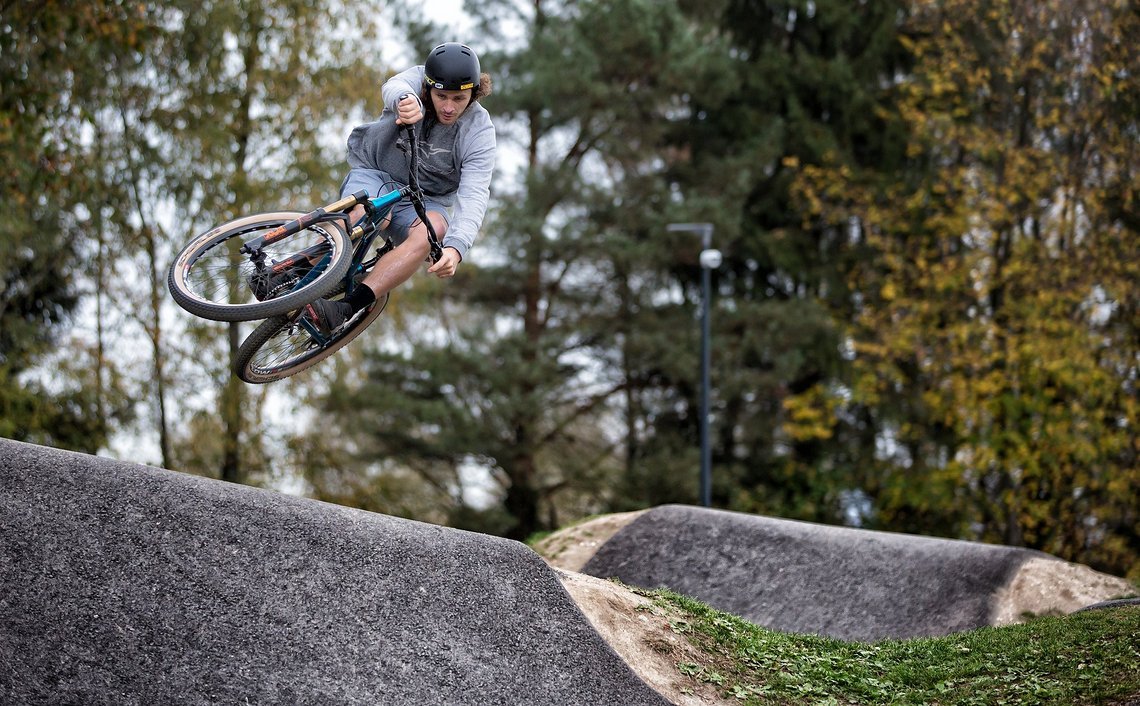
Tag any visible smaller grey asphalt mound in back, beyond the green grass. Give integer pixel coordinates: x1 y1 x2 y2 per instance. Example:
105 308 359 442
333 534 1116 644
581 505 1129 641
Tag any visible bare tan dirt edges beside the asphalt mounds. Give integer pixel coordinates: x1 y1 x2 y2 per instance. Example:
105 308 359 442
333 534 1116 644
535 511 1134 706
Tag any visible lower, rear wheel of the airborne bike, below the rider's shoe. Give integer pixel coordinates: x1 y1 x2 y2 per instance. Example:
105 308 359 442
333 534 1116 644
234 294 389 384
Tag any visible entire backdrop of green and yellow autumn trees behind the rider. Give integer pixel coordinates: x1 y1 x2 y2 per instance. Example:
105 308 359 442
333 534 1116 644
0 0 1140 576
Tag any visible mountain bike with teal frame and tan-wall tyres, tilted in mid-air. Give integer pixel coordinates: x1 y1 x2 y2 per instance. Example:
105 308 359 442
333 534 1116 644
166 125 442 384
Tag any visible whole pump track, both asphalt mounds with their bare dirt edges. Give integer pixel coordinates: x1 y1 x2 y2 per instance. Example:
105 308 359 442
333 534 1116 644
0 439 1131 706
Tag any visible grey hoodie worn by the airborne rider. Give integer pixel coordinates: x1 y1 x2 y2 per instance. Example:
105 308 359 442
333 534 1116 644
348 66 496 257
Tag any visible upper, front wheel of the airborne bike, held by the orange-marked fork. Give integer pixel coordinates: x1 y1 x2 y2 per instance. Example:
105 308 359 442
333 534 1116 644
166 211 352 322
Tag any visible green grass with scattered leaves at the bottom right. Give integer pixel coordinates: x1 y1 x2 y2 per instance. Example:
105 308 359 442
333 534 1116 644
636 590 1140 706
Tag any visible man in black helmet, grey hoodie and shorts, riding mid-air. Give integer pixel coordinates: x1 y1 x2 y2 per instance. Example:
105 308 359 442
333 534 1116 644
304 42 496 333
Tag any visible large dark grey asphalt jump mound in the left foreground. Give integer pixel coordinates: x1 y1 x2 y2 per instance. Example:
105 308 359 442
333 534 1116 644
0 439 666 705
